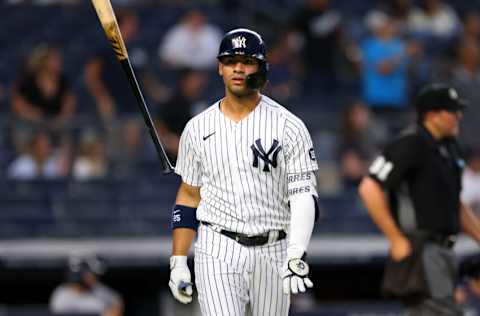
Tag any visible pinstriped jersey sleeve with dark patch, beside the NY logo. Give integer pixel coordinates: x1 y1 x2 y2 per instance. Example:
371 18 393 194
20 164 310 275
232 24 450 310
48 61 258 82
285 120 318 173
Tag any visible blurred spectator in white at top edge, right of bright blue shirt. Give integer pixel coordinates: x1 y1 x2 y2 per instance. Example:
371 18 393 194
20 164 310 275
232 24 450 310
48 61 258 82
408 0 460 39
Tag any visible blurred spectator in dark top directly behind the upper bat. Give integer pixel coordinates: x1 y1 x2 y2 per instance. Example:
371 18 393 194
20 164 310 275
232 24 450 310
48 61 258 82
85 10 147 123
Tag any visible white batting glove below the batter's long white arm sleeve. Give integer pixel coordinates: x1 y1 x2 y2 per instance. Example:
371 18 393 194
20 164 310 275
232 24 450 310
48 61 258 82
283 251 313 295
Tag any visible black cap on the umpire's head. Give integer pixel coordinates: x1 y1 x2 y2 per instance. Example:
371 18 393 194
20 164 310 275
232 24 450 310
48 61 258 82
415 83 467 114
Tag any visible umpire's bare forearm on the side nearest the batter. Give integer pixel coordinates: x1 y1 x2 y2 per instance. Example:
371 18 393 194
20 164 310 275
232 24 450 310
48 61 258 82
358 177 403 242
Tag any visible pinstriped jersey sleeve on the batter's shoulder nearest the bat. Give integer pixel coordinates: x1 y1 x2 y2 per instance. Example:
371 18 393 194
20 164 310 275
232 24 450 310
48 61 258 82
175 121 202 187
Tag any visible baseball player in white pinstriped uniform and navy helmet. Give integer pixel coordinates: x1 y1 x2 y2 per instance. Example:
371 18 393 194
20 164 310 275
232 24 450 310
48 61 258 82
169 29 318 316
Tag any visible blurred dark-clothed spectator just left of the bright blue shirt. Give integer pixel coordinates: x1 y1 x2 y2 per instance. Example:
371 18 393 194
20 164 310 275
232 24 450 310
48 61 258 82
291 0 344 91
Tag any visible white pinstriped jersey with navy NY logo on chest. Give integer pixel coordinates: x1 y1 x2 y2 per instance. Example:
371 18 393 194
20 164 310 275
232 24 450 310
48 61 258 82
175 95 318 235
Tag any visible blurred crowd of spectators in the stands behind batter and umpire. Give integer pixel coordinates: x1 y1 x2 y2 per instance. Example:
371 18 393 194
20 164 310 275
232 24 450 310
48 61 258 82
0 0 480 215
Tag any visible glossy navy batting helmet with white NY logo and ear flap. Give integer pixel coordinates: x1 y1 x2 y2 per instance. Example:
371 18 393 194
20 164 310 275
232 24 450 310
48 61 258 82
217 28 268 89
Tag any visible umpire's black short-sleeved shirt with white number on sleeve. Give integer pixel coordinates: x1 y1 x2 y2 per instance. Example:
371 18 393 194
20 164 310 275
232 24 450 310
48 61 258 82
370 126 464 234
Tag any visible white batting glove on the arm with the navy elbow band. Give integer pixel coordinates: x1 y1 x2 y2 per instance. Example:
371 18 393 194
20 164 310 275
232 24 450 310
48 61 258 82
168 256 193 304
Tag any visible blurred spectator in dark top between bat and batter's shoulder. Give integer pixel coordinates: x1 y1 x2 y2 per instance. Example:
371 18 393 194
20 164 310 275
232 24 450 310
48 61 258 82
157 69 206 160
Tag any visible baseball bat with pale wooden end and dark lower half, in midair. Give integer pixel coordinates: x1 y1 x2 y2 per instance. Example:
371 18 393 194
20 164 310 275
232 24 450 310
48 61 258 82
91 0 173 174
